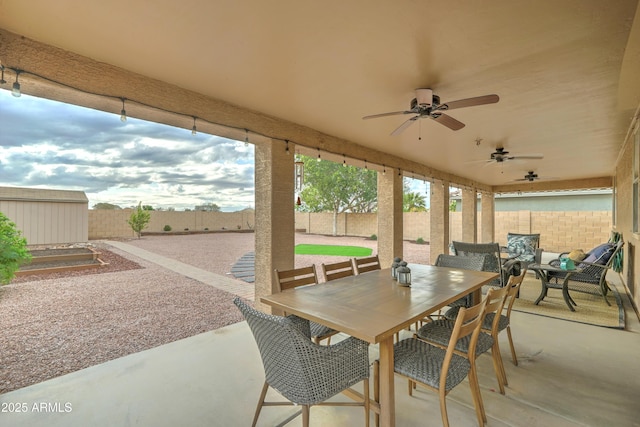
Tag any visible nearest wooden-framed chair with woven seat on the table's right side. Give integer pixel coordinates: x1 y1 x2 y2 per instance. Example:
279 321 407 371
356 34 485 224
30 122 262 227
373 299 486 427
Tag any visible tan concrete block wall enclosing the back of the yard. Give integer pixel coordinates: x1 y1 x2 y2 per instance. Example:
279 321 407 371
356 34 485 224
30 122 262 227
89 209 612 252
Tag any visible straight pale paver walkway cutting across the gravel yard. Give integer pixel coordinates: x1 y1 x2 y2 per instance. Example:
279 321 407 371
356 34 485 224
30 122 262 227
106 240 255 301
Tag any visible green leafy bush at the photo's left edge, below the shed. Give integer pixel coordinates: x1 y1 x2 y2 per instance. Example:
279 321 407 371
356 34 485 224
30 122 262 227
0 212 31 285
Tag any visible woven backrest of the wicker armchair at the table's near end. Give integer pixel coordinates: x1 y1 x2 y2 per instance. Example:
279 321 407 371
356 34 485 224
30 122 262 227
233 297 314 403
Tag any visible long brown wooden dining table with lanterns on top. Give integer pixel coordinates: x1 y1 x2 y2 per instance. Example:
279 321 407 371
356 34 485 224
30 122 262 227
260 264 498 427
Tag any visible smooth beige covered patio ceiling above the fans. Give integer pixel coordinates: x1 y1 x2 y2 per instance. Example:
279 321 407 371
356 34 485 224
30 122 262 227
0 0 640 191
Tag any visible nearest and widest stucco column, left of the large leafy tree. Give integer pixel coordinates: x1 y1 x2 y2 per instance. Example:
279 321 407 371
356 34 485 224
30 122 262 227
255 140 295 312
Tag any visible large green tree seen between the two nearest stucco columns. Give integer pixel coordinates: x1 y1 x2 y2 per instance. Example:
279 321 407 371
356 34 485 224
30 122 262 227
296 156 378 236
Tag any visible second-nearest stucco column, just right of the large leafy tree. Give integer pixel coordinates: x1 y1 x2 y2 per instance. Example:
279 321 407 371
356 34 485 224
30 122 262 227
378 172 403 268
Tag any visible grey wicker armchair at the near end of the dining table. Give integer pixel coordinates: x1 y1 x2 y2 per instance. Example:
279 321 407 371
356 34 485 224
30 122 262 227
233 297 369 427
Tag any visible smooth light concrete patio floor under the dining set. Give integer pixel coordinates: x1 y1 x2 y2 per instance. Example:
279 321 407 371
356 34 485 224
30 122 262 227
0 246 640 427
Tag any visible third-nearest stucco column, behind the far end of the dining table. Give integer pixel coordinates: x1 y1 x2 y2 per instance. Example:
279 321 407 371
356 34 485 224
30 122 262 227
429 181 449 264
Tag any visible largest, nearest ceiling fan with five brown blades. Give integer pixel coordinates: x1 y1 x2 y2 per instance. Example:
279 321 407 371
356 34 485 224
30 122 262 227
363 89 500 136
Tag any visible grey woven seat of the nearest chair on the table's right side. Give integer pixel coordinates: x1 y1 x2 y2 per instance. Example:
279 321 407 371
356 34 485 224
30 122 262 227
393 338 471 391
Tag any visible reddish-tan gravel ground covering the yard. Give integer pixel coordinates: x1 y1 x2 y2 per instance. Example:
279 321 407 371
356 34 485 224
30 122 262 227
0 233 429 394
